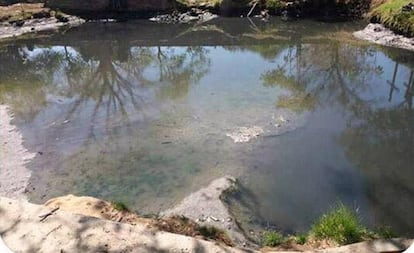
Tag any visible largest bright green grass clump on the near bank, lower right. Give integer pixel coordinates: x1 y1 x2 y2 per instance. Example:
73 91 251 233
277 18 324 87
311 204 366 245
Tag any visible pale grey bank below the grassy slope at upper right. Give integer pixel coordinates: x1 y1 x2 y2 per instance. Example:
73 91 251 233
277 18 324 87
354 24 414 51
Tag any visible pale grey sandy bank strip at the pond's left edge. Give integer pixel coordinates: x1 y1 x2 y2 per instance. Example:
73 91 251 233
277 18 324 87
0 105 35 198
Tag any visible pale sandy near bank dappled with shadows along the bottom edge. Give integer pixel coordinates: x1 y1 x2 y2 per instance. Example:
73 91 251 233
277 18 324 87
0 196 413 253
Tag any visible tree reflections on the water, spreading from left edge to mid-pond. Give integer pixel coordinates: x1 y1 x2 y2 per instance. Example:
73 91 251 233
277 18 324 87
0 42 209 133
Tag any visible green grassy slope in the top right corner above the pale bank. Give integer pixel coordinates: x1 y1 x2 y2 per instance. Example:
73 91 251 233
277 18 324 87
369 0 414 37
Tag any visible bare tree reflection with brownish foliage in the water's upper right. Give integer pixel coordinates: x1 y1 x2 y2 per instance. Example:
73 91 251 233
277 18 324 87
262 43 381 110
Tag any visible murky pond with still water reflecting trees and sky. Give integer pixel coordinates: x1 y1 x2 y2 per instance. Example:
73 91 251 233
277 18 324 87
0 18 414 236
